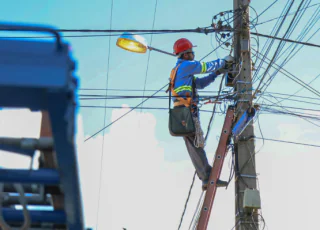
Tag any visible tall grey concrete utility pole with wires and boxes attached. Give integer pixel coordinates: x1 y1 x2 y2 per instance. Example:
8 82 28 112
233 0 260 230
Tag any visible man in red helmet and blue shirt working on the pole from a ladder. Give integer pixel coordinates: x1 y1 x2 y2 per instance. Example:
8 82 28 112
171 38 233 190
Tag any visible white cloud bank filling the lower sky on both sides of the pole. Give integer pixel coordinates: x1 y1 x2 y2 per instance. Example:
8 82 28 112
0 108 320 230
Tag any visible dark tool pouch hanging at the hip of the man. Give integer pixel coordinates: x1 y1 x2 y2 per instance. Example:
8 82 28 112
169 107 196 137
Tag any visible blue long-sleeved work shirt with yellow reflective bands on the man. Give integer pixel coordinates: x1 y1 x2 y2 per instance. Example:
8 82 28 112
172 59 225 104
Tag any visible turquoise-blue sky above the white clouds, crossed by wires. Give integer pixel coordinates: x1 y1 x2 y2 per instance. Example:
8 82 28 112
0 0 320 230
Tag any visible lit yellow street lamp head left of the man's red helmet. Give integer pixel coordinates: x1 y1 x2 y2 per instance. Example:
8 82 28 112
117 32 148 53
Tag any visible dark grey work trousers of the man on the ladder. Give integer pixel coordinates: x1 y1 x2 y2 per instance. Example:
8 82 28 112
183 136 211 181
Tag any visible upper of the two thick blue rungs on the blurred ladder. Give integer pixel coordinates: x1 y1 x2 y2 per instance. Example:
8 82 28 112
0 169 60 185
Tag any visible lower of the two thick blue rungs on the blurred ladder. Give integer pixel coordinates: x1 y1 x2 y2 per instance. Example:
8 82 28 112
2 208 66 224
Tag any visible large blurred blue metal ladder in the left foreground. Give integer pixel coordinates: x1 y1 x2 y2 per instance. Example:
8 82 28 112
0 24 89 230
